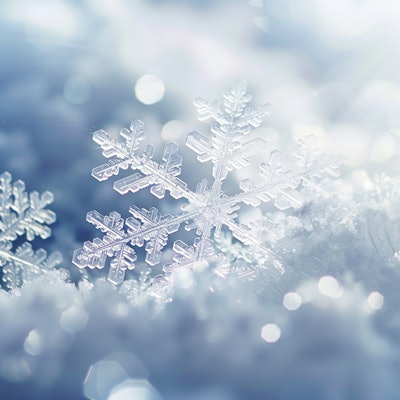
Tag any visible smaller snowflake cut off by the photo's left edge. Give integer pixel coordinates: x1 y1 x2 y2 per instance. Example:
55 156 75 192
0 172 61 290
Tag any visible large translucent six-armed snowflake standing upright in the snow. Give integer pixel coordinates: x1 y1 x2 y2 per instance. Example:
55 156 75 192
73 81 341 287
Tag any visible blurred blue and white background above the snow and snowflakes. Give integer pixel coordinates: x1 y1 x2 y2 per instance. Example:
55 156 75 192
0 0 400 260
